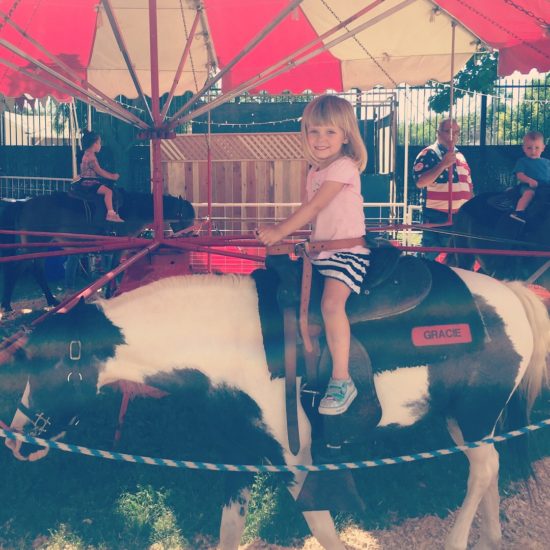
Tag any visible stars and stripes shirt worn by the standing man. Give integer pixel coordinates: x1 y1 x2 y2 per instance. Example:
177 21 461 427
413 142 473 213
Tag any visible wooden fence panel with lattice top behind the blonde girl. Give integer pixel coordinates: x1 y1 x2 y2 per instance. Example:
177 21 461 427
162 136 307 237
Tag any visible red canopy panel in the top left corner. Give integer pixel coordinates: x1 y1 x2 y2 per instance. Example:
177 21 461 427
0 0 98 100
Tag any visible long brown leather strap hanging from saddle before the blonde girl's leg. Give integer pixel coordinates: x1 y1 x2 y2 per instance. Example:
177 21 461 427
283 307 300 455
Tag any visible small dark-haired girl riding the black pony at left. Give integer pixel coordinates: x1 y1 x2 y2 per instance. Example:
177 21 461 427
78 132 124 223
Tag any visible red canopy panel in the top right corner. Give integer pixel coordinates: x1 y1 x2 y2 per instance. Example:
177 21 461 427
436 0 550 76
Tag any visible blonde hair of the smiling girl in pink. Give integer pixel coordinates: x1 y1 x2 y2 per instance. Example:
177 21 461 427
301 95 367 172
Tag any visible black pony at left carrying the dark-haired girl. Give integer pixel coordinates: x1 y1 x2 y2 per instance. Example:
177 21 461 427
0 192 195 311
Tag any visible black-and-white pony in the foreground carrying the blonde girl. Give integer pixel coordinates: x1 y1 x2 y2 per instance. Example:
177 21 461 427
0 262 550 550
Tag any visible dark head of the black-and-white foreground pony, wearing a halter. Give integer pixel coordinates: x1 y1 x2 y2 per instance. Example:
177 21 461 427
6 301 124 460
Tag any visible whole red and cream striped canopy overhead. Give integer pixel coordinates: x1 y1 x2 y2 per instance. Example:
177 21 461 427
0 0 550 113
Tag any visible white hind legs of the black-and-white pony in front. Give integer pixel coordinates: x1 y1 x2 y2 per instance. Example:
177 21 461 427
445 421 501 550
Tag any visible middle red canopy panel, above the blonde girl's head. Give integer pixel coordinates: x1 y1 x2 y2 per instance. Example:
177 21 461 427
205 0 343 93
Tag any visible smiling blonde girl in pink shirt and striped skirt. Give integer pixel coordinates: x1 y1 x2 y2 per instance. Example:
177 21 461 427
257 95 370 415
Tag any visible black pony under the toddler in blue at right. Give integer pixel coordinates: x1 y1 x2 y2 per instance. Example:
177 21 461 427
452 190 550 288
